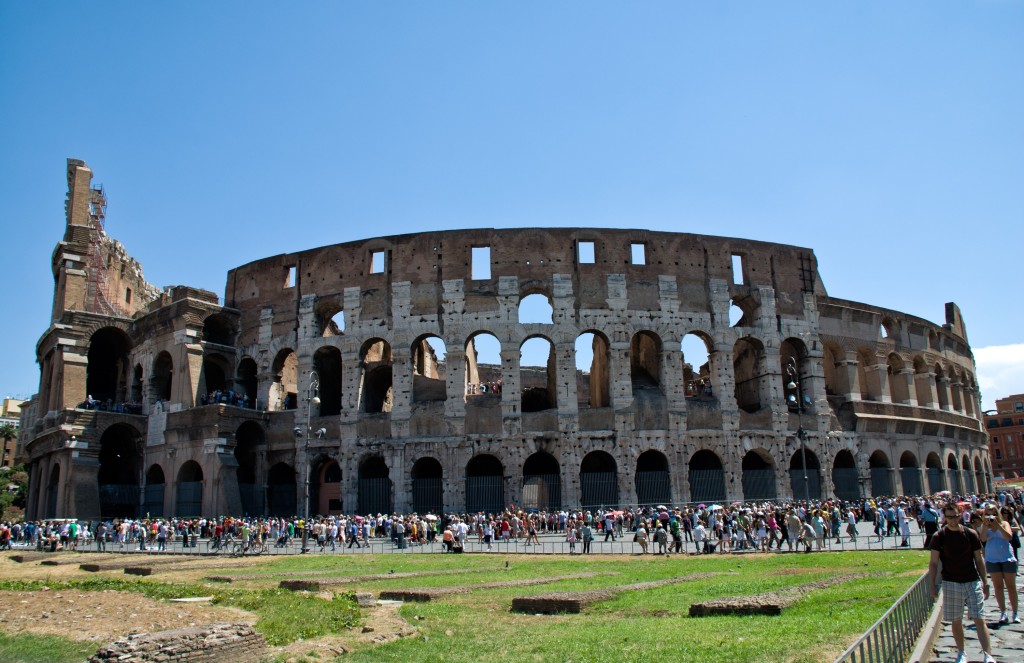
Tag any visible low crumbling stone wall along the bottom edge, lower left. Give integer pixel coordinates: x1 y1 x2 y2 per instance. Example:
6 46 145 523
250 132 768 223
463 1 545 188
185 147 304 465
89 624 266 663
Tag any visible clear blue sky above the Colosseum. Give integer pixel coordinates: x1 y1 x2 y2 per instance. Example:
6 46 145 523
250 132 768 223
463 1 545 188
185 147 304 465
0 0 1024 409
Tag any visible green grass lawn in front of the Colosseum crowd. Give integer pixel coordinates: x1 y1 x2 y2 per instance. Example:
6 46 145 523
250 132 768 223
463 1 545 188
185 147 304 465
0 551 927 663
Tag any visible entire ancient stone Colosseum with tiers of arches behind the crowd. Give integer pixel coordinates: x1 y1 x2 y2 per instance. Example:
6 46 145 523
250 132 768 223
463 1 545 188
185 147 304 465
19 160 991 517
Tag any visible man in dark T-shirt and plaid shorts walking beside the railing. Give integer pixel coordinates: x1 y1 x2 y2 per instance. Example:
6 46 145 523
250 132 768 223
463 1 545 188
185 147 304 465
928 502 994 663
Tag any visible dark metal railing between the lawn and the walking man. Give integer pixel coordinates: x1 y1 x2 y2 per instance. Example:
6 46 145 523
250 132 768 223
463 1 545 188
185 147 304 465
836 573 935 663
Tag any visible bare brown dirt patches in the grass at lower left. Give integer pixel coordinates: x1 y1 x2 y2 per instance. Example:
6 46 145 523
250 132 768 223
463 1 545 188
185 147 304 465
0 556 417 660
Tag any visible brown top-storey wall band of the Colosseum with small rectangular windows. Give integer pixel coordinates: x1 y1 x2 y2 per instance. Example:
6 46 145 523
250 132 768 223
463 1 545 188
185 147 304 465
224 229 821 343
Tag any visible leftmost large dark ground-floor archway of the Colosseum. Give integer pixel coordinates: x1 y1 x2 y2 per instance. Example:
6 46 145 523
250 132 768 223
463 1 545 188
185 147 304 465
97 423 142 517
